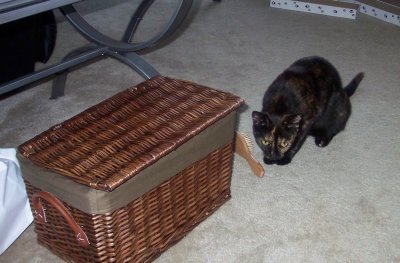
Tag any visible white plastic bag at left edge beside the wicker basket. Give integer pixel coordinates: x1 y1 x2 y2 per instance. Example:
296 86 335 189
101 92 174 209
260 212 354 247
0 148 33 255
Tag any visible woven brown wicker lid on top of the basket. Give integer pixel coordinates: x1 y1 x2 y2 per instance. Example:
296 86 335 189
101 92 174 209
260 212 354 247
19 76 243 191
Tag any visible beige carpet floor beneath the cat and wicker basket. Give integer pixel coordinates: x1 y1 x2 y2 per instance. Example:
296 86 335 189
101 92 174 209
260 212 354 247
0 0 400 263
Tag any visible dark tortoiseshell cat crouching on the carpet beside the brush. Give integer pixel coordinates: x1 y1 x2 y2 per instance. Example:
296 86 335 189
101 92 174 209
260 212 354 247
252 57 364 165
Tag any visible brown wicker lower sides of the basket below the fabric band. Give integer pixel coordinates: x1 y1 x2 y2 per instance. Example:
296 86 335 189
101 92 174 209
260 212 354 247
26 143 233 262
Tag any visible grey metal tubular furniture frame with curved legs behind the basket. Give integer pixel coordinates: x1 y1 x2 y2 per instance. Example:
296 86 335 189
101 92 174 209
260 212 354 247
0 0 194 99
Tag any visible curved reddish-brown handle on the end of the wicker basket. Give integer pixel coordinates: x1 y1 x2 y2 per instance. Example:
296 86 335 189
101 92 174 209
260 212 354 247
32 192 90 247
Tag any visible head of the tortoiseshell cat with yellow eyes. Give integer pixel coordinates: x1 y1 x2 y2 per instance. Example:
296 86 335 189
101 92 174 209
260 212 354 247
252 111 302 164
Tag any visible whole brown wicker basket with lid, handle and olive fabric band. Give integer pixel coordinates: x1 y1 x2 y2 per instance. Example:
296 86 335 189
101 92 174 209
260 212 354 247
18 77 243 262
